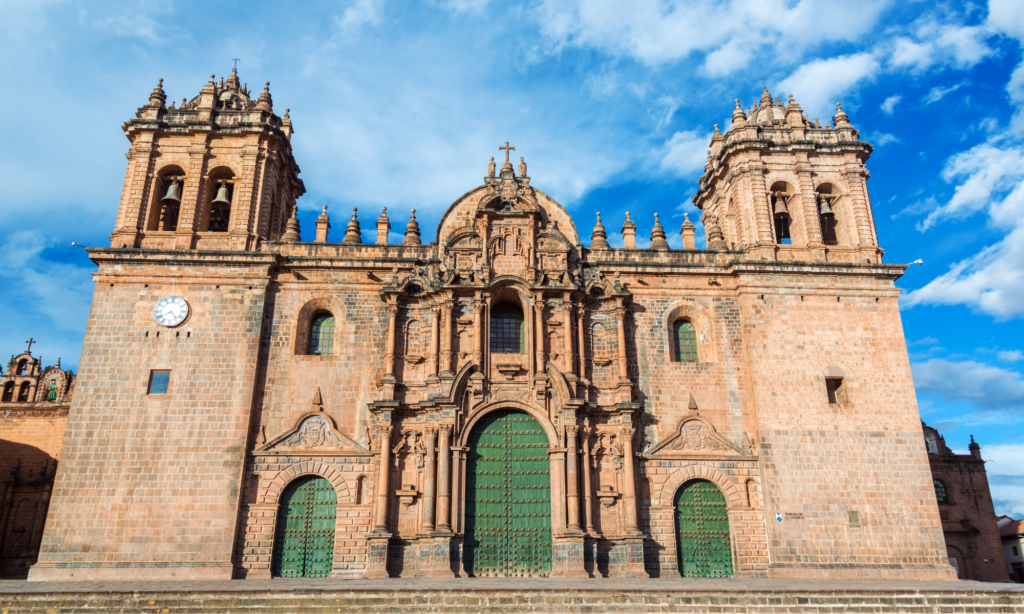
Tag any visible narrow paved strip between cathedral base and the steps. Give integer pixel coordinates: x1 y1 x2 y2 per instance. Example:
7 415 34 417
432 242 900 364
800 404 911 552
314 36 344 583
0 578 1024 595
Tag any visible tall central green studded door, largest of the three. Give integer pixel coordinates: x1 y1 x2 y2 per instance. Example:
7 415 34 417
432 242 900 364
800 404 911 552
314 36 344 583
463 409 551 577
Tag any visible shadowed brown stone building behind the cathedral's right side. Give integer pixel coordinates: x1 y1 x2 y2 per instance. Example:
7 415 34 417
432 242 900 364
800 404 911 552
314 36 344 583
924 426 1010 582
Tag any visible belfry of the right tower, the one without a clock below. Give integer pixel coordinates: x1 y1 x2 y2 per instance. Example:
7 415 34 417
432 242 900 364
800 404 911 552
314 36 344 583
693 88 883 263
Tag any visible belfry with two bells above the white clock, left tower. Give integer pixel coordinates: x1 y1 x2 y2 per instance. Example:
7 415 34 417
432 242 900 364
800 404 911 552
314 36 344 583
111 70 305 250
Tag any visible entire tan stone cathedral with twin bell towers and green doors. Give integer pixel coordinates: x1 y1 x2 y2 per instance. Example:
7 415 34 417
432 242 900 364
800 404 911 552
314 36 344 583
30 71 956 581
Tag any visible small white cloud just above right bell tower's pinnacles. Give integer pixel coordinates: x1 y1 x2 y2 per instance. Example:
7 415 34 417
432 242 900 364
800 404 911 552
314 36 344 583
776 52 879 117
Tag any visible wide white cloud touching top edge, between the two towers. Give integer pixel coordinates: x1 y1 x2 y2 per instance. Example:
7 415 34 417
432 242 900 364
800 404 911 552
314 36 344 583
538 0 891 75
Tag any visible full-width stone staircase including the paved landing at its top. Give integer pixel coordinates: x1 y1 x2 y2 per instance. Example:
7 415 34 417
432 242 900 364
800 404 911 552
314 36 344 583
0 580 1024 614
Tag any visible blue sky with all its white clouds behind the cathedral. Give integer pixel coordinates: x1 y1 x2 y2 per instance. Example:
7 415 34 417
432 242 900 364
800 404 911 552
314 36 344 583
0 0 1024 517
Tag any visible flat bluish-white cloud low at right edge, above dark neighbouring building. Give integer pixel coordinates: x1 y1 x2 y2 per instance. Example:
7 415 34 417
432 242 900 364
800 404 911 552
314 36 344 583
910 358 1024 411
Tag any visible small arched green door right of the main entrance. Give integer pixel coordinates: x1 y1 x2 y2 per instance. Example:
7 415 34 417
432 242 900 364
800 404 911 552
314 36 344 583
676 480 732 578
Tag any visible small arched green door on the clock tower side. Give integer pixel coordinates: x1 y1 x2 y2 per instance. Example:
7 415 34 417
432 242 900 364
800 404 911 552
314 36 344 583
270 476 338 578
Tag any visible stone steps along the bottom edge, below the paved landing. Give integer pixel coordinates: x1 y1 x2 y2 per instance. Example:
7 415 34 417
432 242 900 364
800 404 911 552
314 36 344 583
0 583 1024 614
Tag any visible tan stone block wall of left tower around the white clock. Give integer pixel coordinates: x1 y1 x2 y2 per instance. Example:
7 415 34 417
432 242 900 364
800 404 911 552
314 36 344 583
30 250 268 579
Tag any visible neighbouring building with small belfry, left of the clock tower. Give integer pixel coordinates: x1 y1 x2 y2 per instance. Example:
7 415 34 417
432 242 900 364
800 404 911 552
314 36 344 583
0 343 75 578
